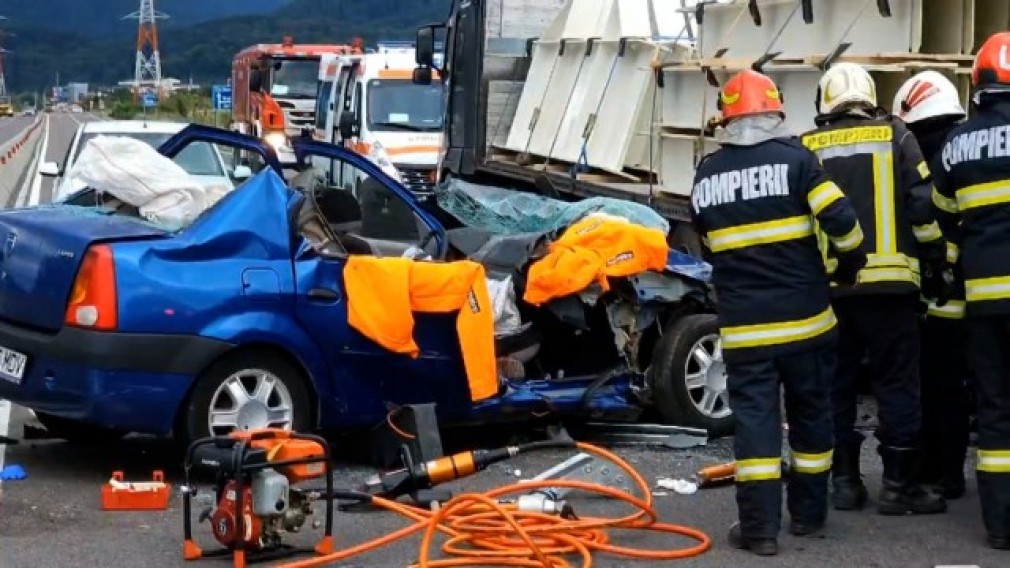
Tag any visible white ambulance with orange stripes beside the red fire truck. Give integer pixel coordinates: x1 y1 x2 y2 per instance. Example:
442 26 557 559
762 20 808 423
313 43 444 194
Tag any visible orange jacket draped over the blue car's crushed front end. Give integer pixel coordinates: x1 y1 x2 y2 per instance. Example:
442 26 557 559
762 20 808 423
522 213 670 306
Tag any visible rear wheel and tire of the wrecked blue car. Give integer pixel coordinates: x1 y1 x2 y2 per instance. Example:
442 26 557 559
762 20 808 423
177 352 314 444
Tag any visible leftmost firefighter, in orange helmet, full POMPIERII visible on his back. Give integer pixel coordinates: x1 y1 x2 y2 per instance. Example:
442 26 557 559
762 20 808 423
691 70 866 556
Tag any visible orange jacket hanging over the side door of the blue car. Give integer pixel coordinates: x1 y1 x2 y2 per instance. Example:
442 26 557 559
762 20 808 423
343 256 498 401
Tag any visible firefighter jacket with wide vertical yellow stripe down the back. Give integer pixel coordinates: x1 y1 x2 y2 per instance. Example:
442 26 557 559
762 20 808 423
802 114 945 295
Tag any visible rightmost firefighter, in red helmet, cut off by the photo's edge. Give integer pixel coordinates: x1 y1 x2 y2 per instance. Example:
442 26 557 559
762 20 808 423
931 31 1010 550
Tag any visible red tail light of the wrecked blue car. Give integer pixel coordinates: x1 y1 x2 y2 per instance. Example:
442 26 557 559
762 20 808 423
64 245 119 330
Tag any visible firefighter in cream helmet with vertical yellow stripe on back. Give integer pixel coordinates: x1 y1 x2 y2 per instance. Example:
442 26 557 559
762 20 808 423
802 63 947 514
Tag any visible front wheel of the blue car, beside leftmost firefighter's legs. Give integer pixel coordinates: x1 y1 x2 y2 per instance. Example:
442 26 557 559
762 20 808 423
647 313 733 438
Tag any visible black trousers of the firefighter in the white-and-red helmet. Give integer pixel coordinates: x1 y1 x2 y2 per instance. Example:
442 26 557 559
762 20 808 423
920 316 974 483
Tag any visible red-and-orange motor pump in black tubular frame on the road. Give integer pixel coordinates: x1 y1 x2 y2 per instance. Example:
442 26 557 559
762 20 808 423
182 429 333 568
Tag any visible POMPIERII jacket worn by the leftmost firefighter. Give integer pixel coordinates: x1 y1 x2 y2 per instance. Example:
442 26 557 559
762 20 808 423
691 137 863 363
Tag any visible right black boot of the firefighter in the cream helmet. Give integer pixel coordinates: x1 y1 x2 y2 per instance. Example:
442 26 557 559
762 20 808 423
877 446 946 514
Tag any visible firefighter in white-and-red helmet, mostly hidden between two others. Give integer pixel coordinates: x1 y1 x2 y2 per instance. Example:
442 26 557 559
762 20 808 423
892 71 971 499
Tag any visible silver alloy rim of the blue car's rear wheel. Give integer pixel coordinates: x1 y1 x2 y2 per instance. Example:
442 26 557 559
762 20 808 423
207 369 295 436
